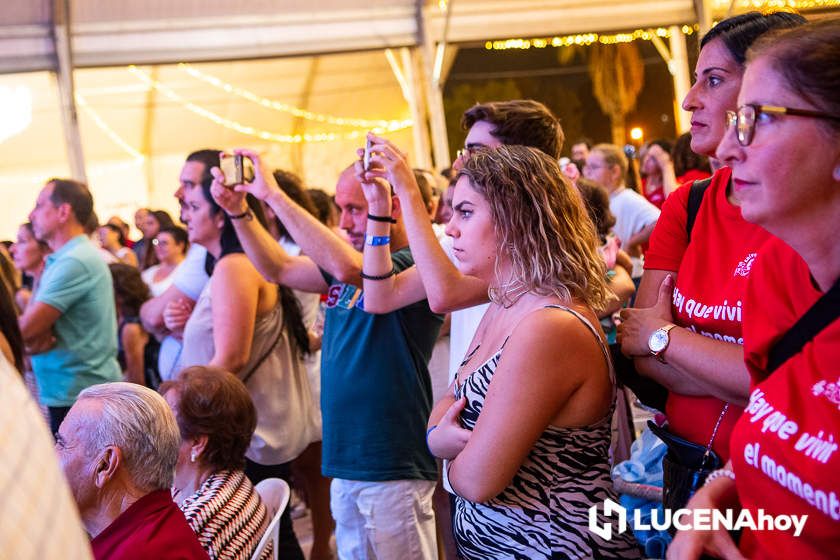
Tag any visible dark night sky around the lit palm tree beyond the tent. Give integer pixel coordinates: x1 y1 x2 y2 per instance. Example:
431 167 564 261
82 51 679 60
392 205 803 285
444 36 697 159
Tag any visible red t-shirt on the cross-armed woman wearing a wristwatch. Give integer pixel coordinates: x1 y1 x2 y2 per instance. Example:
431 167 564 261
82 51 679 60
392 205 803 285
645 167 770 461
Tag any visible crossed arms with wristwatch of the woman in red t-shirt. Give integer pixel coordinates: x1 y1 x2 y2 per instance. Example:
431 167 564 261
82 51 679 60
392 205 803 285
618 270 749 406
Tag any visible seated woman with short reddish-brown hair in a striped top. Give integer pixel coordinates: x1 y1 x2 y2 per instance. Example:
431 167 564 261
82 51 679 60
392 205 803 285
160 366 272 560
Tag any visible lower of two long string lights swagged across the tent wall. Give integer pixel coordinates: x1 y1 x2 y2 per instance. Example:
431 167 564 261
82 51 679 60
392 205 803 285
127 65 411 144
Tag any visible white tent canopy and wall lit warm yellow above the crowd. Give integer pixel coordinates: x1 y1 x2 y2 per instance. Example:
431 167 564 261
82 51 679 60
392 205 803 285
0 0 760 238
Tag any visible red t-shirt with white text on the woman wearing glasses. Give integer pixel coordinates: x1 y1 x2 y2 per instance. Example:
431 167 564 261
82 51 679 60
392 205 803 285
730 239 840 560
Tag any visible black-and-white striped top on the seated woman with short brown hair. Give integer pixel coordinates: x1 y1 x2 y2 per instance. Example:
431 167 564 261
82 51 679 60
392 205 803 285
181 470 272 560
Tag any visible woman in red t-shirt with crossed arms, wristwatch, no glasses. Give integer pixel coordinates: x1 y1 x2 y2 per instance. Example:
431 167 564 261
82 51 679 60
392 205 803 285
619 12 805 461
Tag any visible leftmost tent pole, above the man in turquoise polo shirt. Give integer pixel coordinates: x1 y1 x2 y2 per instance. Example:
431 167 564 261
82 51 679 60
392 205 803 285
52 0 87 183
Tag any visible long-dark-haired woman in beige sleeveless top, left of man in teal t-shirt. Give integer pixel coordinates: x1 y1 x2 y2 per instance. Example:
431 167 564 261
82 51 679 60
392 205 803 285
180 170 318 559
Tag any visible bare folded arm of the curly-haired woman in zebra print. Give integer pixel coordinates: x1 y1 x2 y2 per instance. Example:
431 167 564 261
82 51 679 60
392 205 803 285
442 309 608 502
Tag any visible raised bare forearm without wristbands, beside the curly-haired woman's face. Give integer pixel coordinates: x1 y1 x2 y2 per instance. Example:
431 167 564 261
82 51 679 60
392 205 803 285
357 134 487 313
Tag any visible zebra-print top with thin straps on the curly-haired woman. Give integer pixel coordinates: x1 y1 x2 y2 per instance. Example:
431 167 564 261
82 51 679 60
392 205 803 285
444 306 640 560
